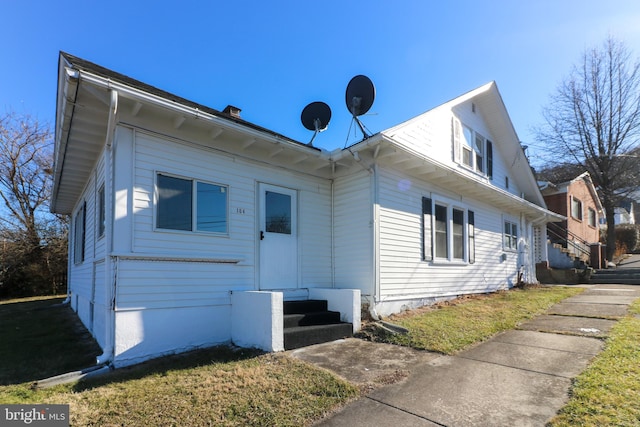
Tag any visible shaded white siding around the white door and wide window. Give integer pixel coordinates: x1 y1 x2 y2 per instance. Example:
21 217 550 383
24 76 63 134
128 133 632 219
118 132 332 308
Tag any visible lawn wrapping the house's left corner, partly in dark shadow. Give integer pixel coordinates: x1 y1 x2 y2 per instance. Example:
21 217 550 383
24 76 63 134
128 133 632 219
0 299 360 426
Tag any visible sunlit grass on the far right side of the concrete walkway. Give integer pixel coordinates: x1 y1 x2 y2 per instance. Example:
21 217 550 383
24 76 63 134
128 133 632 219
550 300 640 427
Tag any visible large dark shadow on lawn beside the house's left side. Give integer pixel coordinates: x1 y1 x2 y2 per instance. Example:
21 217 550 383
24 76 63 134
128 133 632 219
0 297 102 385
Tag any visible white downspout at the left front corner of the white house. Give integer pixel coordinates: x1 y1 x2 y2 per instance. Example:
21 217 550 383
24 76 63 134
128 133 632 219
96 89 118 365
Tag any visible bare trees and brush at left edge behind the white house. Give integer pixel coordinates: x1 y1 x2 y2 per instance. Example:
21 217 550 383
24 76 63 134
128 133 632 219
0 112 67 296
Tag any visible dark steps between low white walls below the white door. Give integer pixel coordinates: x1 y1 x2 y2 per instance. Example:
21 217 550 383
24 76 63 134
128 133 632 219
284 300 353 350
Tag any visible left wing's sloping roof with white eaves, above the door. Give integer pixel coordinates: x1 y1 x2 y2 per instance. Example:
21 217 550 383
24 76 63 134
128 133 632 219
51 52 329 214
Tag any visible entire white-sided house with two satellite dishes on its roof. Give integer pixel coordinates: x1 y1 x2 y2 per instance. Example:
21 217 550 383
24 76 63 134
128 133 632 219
52 53 562 366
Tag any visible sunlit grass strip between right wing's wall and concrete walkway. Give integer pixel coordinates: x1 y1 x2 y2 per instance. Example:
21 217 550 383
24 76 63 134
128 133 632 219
365 286 584 355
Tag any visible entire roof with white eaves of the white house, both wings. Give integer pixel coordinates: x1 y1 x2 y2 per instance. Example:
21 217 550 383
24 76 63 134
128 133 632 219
51 52 564 221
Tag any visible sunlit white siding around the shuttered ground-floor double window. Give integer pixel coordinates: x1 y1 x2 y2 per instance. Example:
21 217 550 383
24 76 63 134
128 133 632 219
378 169 517 301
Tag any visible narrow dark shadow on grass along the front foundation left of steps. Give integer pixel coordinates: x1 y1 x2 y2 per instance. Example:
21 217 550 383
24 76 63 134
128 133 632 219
73 345 265 392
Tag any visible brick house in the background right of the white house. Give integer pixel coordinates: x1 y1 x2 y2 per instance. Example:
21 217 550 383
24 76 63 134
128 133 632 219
538 172 604 267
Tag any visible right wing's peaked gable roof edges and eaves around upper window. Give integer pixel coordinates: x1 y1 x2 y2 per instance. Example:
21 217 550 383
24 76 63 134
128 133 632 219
332 82 566 223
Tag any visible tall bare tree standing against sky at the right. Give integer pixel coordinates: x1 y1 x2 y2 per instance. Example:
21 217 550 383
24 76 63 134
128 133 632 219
537 37 640 259
